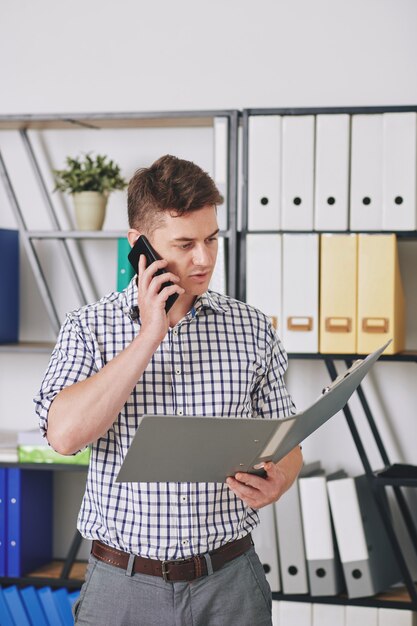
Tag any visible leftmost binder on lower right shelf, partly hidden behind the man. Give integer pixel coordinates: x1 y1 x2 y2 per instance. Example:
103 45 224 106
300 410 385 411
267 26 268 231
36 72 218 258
252 504 281 592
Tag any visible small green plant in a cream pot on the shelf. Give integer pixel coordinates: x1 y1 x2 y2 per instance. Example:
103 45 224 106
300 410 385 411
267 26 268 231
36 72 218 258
52 154 127 230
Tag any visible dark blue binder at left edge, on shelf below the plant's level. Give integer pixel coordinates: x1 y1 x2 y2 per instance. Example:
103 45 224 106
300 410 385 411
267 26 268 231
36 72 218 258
0 228 19 343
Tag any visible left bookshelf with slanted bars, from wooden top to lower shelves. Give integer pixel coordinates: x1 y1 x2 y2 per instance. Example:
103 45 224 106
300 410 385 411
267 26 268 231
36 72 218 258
0 110 239 589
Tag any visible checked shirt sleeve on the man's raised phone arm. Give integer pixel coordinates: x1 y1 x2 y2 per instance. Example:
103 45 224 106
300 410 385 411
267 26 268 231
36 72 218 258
33 315 98 437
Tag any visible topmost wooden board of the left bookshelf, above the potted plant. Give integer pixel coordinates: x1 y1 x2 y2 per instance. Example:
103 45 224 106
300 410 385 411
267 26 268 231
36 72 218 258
0 110 236 130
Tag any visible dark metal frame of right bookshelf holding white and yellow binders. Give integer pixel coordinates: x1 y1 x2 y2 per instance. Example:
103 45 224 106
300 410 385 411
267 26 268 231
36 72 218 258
238 106 417 610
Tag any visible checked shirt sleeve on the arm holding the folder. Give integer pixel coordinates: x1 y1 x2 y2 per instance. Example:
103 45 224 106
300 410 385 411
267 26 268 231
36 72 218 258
252 322 296 419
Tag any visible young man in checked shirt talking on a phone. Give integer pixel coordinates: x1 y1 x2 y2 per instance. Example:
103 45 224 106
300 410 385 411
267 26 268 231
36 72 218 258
35 155 302 626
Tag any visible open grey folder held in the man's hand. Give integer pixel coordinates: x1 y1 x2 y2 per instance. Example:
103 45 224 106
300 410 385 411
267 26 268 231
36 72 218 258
116 342 390 482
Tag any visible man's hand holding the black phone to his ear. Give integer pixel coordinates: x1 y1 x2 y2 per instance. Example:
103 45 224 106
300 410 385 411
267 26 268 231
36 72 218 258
138 254 185 345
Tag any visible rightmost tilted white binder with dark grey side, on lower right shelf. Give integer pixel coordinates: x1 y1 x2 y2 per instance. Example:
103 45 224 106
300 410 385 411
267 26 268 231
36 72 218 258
327 475 401 598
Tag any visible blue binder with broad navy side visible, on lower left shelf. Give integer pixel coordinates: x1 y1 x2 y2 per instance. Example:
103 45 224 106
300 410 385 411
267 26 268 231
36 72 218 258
7 467 52 578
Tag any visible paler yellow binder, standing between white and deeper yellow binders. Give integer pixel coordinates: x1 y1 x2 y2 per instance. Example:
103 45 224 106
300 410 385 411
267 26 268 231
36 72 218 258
320 234 357 354
